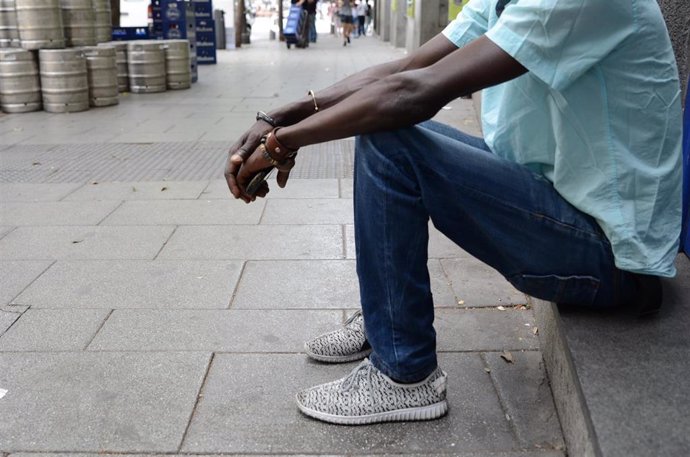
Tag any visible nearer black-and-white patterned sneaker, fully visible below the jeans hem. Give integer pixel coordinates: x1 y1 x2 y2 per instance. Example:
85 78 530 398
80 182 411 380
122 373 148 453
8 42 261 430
297 359 448 425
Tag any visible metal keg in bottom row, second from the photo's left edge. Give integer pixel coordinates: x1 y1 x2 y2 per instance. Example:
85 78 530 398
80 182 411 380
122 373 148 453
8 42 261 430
38 48 89 113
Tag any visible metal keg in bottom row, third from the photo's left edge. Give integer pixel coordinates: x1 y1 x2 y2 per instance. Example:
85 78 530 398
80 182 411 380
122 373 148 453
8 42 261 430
84 46 119 106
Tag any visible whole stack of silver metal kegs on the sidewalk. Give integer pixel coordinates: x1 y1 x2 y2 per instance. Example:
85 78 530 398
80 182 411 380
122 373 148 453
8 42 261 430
0 0 196 113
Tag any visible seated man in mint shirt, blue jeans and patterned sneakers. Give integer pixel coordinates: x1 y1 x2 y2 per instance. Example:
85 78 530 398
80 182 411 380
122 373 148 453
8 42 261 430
226 0 682 424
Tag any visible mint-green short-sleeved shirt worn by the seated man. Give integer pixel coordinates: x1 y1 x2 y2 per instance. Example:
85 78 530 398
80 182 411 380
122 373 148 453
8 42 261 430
443 0 682 277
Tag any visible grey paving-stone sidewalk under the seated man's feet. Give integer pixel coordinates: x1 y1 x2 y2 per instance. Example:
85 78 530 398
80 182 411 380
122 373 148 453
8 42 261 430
0 36 565 457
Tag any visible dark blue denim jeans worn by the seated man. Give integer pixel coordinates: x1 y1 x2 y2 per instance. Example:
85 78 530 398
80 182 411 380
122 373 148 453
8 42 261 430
354 121 632 382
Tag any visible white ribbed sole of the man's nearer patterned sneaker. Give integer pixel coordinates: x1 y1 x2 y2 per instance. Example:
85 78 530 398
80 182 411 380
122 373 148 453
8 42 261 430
297 400 448 425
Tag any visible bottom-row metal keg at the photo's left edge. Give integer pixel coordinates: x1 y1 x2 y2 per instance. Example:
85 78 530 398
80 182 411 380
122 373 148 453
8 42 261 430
0 49 41 113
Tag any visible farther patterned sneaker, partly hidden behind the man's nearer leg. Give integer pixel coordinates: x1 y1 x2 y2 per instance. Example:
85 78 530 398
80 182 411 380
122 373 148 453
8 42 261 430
304 311 371 363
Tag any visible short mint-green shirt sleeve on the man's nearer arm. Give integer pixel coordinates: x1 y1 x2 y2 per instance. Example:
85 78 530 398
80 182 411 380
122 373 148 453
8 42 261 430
486 0 636 90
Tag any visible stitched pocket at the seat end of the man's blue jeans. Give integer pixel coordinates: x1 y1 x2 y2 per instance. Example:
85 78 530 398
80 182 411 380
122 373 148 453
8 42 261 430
508 275 600 306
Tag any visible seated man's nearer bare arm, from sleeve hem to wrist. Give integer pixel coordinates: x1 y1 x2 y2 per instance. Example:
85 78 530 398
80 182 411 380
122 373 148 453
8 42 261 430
277 37 527 149
